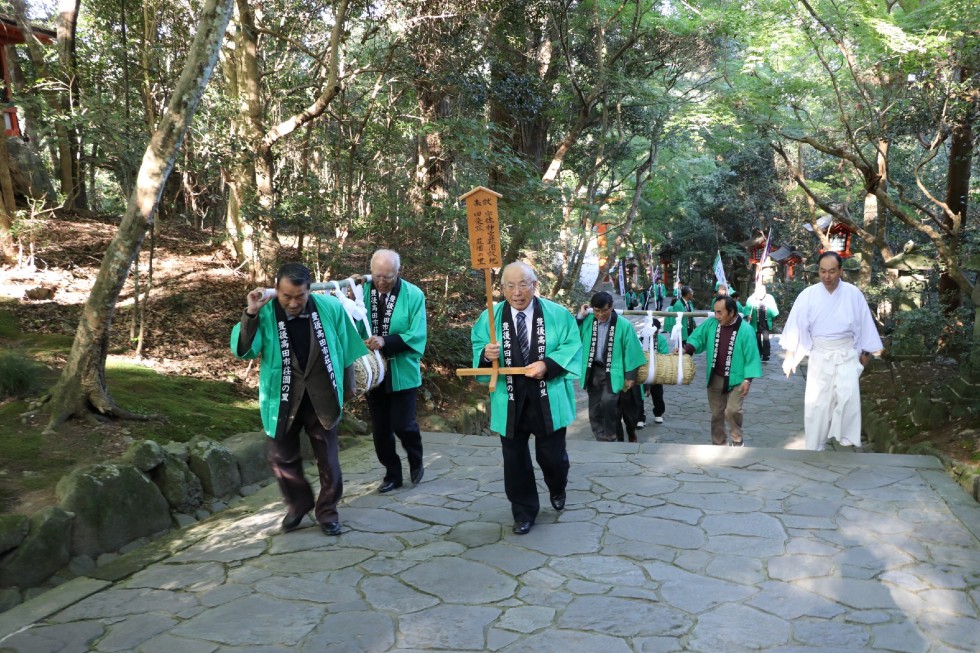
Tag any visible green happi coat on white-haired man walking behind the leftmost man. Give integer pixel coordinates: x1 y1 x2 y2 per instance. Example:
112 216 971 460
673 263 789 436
357 278 429 392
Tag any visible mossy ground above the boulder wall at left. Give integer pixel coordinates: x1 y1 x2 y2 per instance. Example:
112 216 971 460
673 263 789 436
0 320 261 514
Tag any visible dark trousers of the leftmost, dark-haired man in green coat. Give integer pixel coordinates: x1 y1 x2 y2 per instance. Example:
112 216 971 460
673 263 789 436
269 394 344 524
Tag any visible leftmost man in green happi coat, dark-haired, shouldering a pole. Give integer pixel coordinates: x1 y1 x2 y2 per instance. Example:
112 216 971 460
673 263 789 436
231 263 368 535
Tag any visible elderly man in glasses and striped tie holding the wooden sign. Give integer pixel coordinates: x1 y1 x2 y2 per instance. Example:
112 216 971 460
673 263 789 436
470 262 582 535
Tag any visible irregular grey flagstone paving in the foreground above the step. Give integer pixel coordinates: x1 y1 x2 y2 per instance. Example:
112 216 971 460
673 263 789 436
0 430 980 653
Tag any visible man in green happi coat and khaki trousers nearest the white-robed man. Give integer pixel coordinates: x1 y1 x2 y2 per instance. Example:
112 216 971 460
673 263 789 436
684 296 762 447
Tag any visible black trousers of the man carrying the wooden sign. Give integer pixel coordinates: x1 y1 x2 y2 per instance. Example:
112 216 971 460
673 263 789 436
500 390 569 522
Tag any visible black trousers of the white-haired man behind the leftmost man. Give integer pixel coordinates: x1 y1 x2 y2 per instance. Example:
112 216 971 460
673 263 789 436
367 388 422 483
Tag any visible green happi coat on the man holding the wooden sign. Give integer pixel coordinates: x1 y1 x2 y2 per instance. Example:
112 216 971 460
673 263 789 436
470 297 582 436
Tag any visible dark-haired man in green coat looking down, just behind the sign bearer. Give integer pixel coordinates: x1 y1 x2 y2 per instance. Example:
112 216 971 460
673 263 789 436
577 292 647 442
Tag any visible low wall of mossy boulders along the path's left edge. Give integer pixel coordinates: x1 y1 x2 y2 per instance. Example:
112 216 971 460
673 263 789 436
0 432 294 612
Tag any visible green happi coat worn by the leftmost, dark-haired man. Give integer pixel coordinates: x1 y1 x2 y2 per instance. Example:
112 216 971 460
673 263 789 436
231 294 368 438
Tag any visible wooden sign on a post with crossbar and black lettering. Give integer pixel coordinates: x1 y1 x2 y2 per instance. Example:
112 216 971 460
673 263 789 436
456 186 525 392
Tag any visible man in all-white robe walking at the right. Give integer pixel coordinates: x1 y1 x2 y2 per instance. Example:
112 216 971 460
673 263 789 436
780 252 882 451
